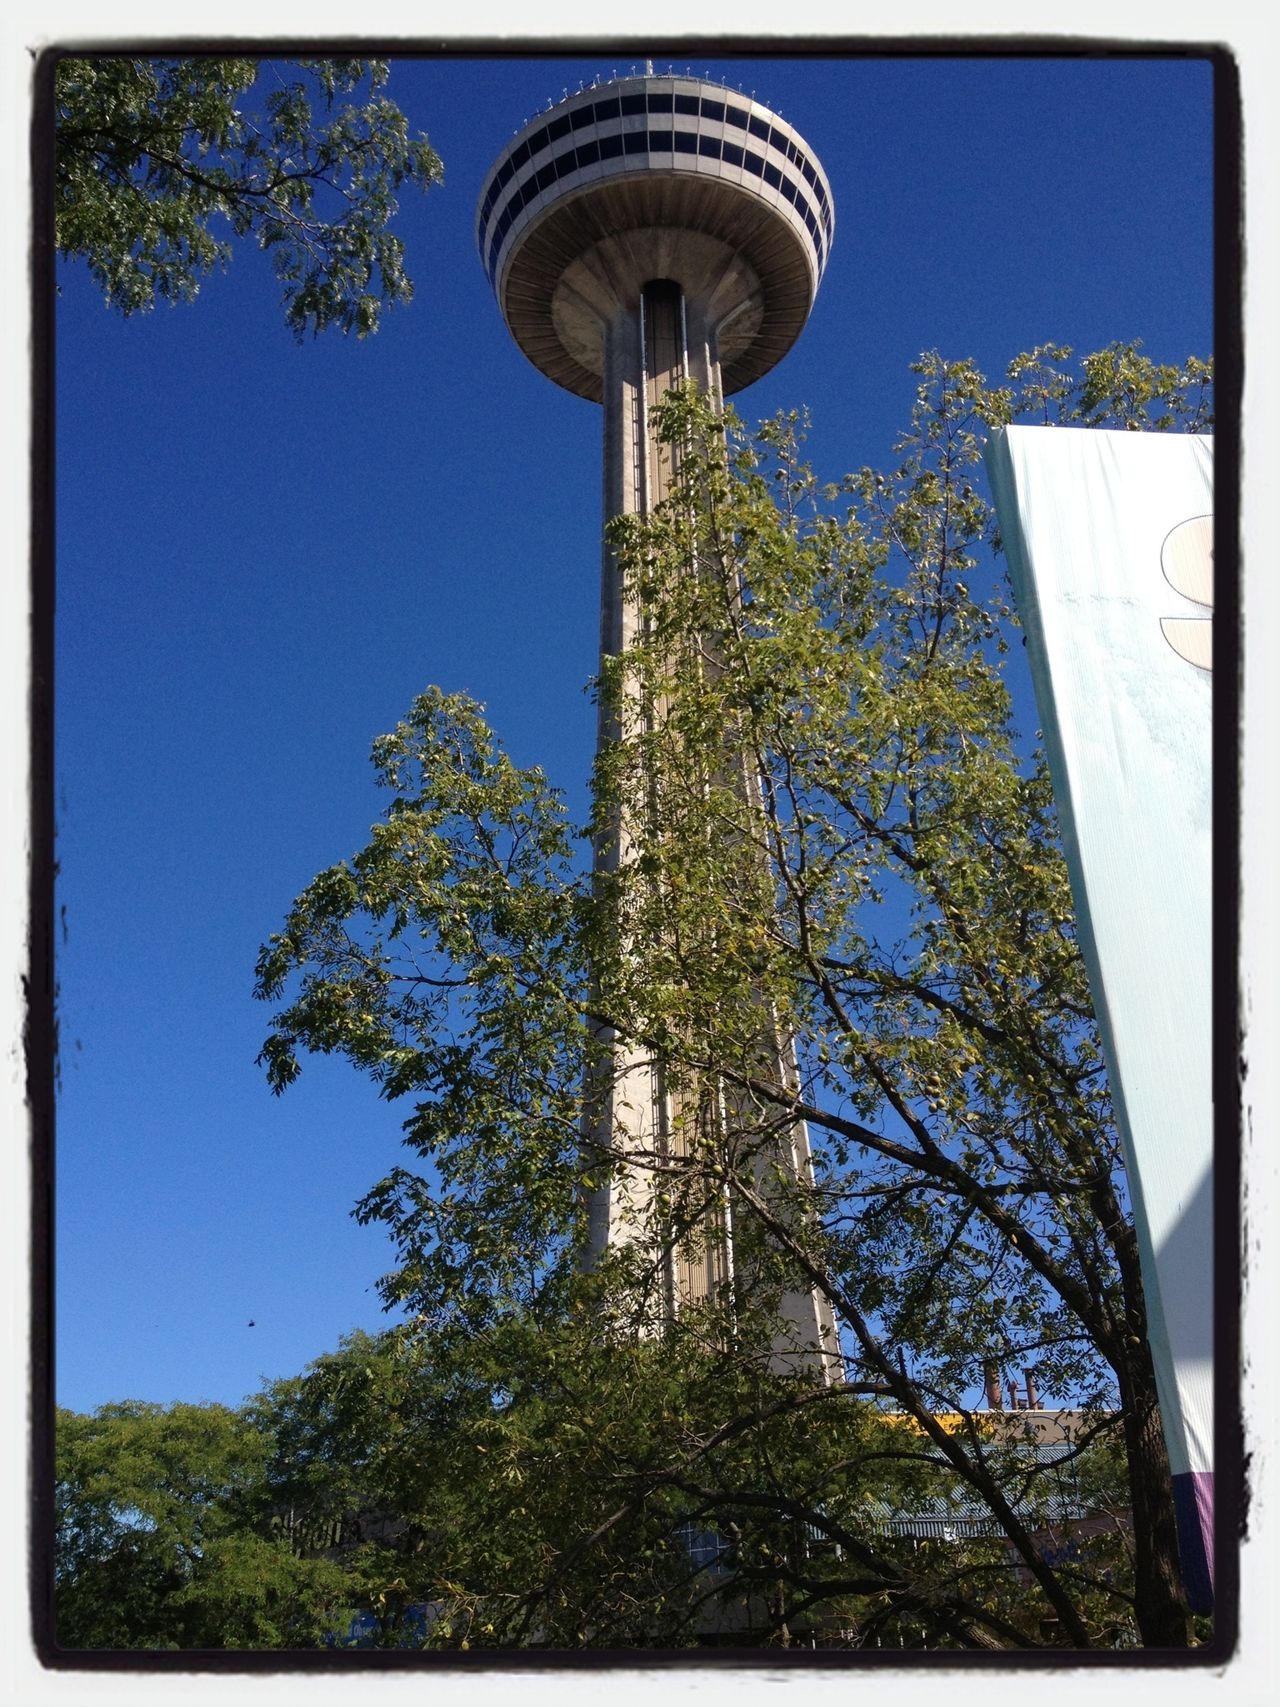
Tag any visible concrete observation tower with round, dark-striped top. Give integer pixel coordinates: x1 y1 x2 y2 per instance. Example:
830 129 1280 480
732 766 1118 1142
476 68 835 1354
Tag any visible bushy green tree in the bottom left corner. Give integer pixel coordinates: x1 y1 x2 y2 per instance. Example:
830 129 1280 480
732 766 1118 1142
55 1333 476 1649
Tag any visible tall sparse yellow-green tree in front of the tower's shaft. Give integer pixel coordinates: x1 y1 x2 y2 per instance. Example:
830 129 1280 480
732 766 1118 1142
258 345 1212 1647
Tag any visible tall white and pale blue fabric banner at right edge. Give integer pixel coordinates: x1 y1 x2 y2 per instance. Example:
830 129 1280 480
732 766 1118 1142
986 427 1213 1608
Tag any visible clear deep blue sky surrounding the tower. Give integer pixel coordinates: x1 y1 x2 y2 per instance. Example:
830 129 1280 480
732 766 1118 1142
55 55 1212 1408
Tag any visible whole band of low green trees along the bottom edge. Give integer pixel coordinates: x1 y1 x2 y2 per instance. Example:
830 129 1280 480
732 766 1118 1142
55 1304 1125 1651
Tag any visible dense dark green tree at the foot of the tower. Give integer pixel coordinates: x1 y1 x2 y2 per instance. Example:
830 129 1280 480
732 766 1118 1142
373 1282 1140 1649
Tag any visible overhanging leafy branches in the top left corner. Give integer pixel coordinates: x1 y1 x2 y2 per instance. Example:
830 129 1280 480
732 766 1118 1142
53 55 442 340
